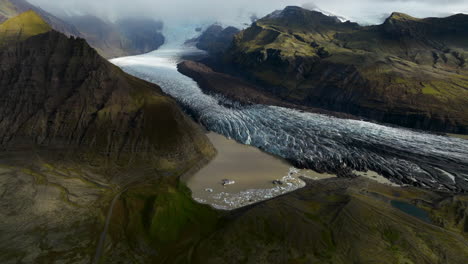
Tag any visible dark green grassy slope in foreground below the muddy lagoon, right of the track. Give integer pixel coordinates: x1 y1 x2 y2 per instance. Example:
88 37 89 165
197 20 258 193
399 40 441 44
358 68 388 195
99 178 468 264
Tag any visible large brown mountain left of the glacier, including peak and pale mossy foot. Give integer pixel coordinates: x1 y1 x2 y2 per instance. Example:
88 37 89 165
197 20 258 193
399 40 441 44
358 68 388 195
0 11 214 263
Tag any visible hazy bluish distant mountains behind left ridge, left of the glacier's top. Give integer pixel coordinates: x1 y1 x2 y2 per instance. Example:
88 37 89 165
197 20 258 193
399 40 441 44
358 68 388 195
0 0 164 58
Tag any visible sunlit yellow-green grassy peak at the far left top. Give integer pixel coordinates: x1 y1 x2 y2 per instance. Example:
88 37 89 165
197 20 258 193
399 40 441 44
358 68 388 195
0 11 52 45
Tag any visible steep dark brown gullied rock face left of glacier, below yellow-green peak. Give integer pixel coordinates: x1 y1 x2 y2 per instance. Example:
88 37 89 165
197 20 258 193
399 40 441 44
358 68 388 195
0 28 209 167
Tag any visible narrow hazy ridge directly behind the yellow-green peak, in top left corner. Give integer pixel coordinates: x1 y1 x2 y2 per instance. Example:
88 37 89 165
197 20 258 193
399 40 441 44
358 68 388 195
0 0 80 36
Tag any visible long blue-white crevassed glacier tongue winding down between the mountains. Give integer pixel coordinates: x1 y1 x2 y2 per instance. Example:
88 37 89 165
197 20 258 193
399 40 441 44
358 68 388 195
112 28 468 192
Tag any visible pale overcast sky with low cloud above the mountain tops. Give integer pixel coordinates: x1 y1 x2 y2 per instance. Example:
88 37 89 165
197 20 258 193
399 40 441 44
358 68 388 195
29 0 468 24
